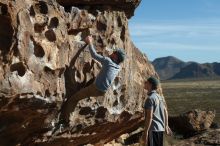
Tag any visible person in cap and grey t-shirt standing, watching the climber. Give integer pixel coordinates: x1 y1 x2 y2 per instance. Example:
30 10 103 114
140 77 172 146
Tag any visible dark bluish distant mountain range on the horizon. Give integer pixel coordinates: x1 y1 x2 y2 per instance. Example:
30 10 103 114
152 56 220 80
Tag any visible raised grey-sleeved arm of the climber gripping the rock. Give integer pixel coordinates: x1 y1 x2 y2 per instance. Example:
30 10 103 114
85 36 104 62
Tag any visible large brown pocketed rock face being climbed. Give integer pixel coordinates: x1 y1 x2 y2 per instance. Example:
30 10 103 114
0 0 156 146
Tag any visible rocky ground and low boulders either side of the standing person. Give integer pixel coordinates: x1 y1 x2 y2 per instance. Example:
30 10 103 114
103 109 220 146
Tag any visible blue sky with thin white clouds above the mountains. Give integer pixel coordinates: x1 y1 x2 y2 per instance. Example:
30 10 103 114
129 0 220 63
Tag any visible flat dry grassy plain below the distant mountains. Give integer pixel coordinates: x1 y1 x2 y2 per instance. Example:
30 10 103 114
162 79 220 123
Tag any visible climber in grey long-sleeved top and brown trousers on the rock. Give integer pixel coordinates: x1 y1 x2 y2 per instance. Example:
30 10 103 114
52 36 125 132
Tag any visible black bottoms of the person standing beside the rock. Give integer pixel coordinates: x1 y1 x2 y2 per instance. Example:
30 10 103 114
148 131 164 146
